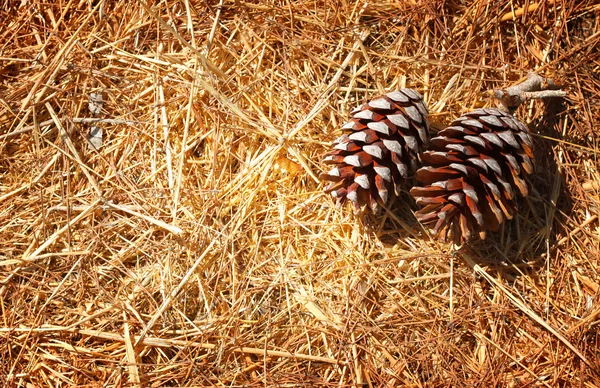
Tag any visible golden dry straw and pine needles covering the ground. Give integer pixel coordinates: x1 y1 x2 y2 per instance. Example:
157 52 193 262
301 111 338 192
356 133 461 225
0 0 600 387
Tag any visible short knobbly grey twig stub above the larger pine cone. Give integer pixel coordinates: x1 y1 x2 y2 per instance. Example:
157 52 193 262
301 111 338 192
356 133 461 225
490 71 567 114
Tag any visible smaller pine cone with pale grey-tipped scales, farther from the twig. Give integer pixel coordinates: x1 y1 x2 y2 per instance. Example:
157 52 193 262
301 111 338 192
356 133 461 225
320 89 429 212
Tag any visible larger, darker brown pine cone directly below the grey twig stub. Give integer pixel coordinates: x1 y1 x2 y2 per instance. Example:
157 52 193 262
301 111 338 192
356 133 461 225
410 109 533 243
